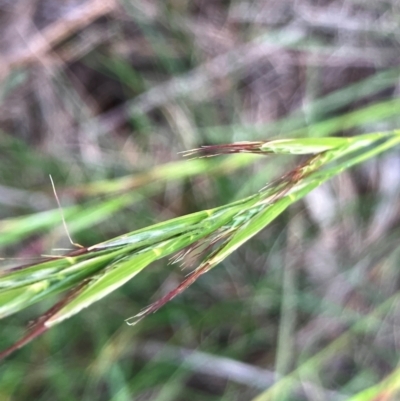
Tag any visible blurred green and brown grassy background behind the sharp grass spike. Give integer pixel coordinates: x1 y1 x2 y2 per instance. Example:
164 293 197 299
0 0 400 401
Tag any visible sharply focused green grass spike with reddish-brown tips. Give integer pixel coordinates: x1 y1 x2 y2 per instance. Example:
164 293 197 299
0 131 400 358
